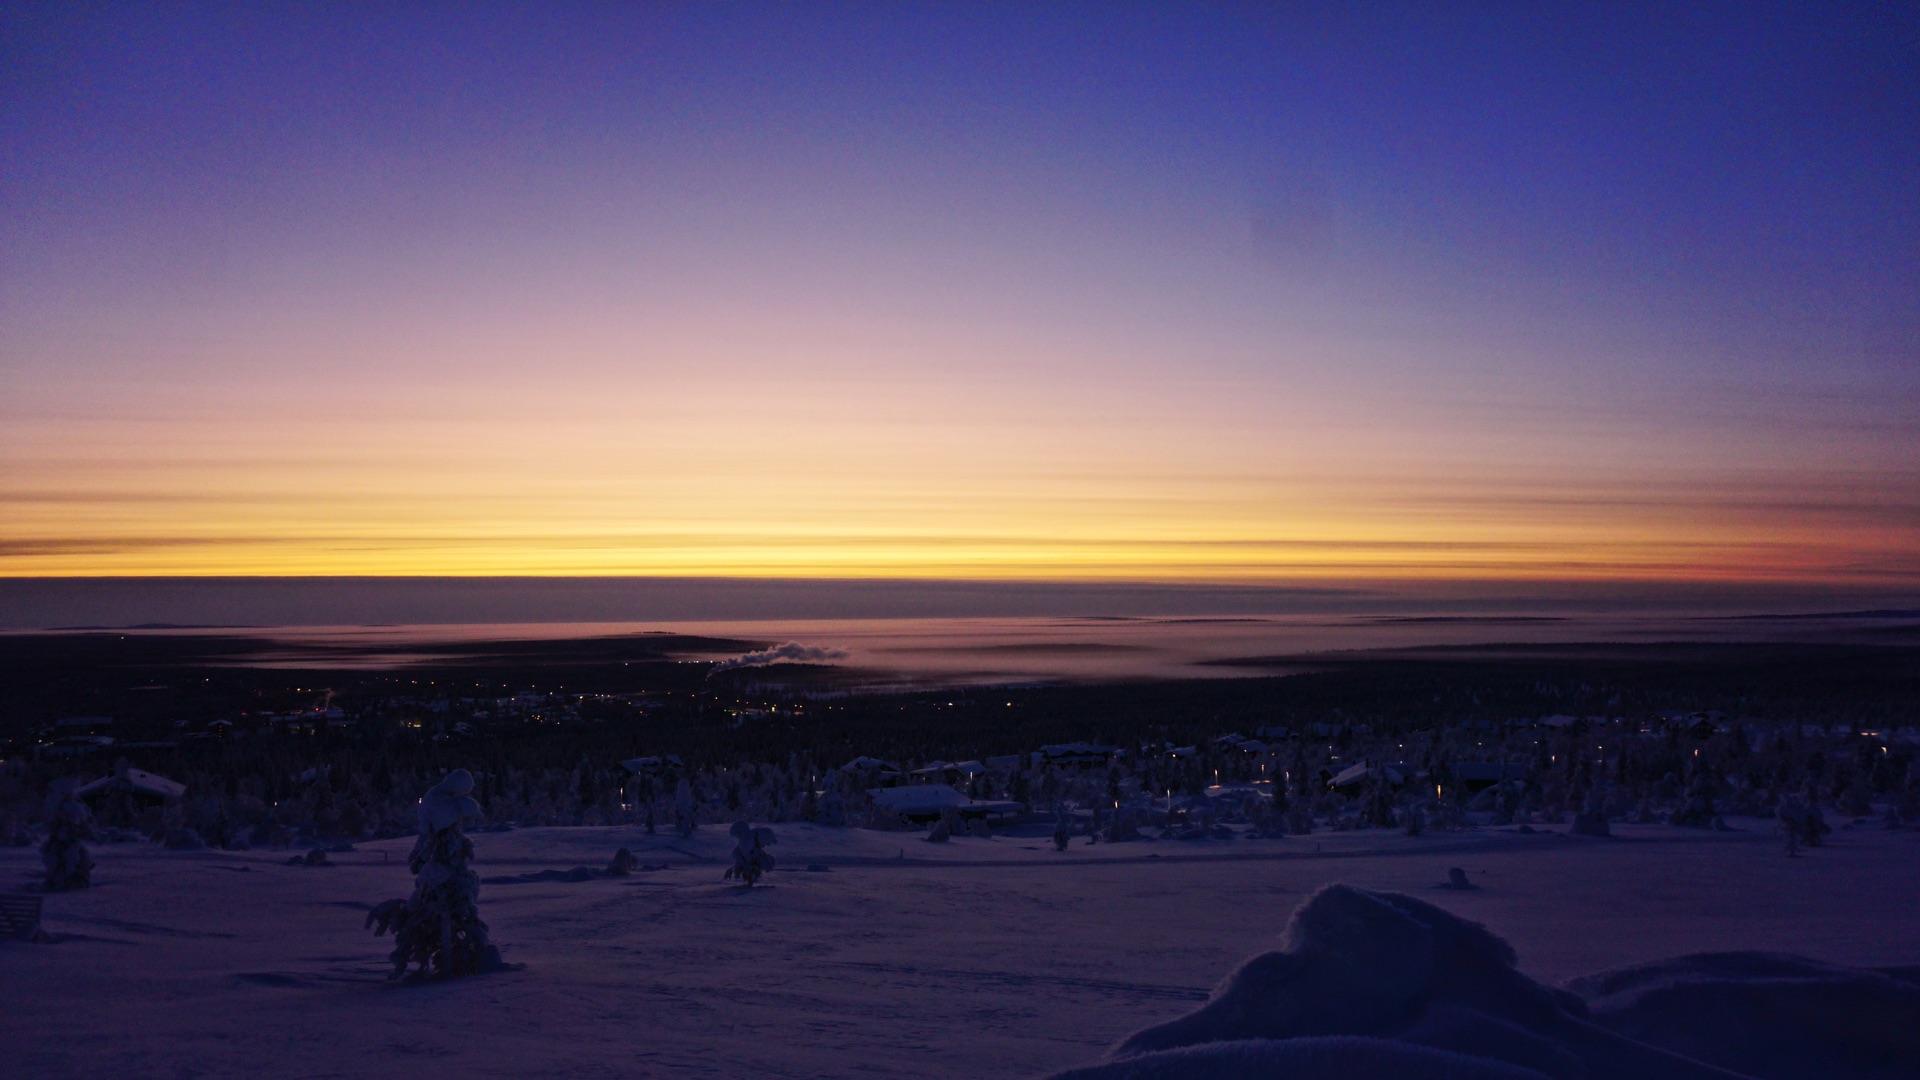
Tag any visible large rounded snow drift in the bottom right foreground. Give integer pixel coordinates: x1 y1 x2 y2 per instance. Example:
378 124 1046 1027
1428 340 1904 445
1056 886 1920 1080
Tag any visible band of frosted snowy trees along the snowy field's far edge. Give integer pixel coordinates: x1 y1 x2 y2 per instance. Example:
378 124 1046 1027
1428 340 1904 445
0 721 1920 847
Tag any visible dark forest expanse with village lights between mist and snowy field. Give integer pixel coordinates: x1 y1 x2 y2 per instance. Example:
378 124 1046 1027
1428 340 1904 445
0 636 1920 844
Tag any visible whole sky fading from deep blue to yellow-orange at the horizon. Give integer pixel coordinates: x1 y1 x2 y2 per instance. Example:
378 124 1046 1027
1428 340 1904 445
0 2 1920 594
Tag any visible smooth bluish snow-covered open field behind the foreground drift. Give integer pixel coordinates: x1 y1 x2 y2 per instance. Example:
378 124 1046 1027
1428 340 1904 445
0 819 1920 1080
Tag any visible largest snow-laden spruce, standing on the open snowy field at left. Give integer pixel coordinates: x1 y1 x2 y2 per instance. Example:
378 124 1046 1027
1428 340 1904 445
367 769 501 978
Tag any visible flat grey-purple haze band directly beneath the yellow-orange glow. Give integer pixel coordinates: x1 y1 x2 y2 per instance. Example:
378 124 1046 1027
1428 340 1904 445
0 575 1920 630
